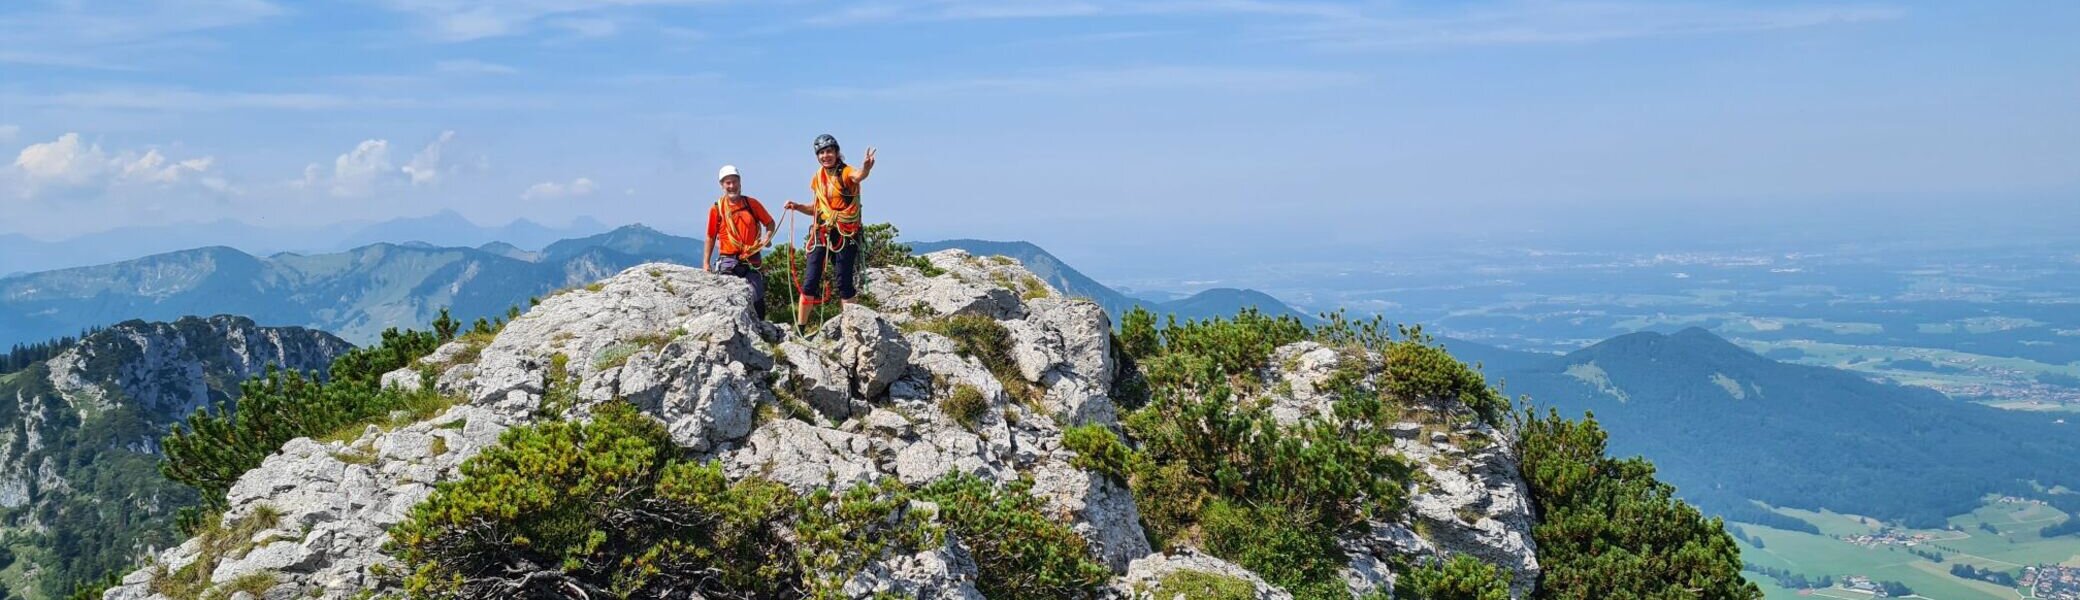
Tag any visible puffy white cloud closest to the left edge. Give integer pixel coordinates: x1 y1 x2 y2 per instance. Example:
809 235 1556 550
12 133 231 196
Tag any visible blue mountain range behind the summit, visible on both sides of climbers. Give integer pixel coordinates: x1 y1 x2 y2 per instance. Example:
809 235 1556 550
0 226 1317 346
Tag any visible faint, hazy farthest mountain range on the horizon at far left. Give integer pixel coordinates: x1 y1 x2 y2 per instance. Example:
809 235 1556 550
0 210 609 273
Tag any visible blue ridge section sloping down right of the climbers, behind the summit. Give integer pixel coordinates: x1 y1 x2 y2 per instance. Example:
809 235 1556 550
911 240 1319 323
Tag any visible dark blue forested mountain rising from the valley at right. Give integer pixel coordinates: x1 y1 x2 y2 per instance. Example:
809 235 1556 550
1489 329 2080 529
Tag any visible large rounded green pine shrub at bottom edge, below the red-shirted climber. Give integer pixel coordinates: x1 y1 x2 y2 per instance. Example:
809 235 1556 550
391 402 801 598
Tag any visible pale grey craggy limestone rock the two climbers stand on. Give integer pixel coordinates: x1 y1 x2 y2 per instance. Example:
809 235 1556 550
104 250 1539 600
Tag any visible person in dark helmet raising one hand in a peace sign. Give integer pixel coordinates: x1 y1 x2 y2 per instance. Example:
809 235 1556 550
784 133 874 327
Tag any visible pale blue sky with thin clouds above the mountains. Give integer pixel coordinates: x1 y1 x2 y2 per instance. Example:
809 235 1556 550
0 0 2080 266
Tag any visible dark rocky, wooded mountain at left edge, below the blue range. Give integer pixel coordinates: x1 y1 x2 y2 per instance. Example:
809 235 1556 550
0 317 352 598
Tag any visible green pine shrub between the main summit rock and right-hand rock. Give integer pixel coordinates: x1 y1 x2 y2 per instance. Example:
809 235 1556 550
1114 310 1539 598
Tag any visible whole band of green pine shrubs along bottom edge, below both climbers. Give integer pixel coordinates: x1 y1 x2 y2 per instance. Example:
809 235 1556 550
391 402 1111 598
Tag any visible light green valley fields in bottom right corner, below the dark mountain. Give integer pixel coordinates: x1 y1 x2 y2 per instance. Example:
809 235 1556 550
1731 500 2080 600
